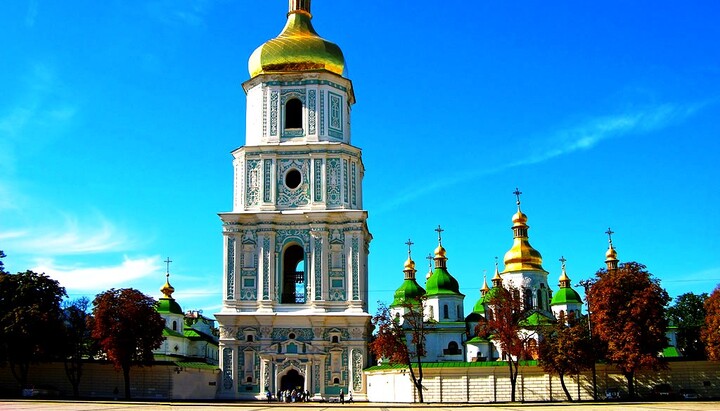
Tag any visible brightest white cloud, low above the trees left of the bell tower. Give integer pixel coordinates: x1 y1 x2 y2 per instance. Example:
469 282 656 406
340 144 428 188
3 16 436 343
32 256 162 292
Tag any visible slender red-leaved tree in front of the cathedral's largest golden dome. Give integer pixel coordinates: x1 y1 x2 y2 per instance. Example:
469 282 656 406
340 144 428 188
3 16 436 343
476 285 537 402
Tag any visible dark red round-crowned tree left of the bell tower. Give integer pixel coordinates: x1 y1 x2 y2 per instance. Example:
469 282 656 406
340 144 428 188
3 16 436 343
92 288 165 399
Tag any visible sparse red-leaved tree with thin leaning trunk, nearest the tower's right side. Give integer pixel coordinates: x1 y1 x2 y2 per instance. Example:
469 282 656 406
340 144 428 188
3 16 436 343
369 298 428 402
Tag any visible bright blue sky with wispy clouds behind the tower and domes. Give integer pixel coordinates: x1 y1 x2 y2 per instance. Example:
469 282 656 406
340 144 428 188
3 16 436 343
0 0 720 313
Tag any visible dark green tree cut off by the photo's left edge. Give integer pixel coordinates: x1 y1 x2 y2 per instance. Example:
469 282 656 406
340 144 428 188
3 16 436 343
0 271 66 388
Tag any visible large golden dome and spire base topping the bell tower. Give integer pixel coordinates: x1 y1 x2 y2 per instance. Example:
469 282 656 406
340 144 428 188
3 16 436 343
248 0 345 77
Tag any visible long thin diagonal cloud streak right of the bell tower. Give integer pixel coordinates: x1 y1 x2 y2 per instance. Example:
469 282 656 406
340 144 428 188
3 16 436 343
375 103 707 214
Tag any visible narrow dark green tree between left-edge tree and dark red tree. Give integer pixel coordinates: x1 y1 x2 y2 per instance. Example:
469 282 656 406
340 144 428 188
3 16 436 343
62 297 96 398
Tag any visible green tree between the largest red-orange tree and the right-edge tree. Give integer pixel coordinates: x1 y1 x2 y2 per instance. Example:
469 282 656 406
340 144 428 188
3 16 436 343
668 293 708 360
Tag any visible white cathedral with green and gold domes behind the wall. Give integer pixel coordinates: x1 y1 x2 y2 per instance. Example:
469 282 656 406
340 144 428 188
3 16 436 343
390 190 584 362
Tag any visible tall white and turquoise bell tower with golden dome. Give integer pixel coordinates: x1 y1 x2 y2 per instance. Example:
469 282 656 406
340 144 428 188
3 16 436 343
215 0 372 400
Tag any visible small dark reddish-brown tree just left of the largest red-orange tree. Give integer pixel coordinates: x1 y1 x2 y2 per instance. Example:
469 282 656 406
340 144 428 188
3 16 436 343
538 314 595 401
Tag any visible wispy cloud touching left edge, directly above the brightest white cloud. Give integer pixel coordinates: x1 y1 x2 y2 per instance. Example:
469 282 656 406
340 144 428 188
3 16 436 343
0 214 132 256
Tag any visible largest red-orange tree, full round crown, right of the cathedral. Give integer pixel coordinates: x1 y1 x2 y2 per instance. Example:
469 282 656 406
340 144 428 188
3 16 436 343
587 262 670 397
